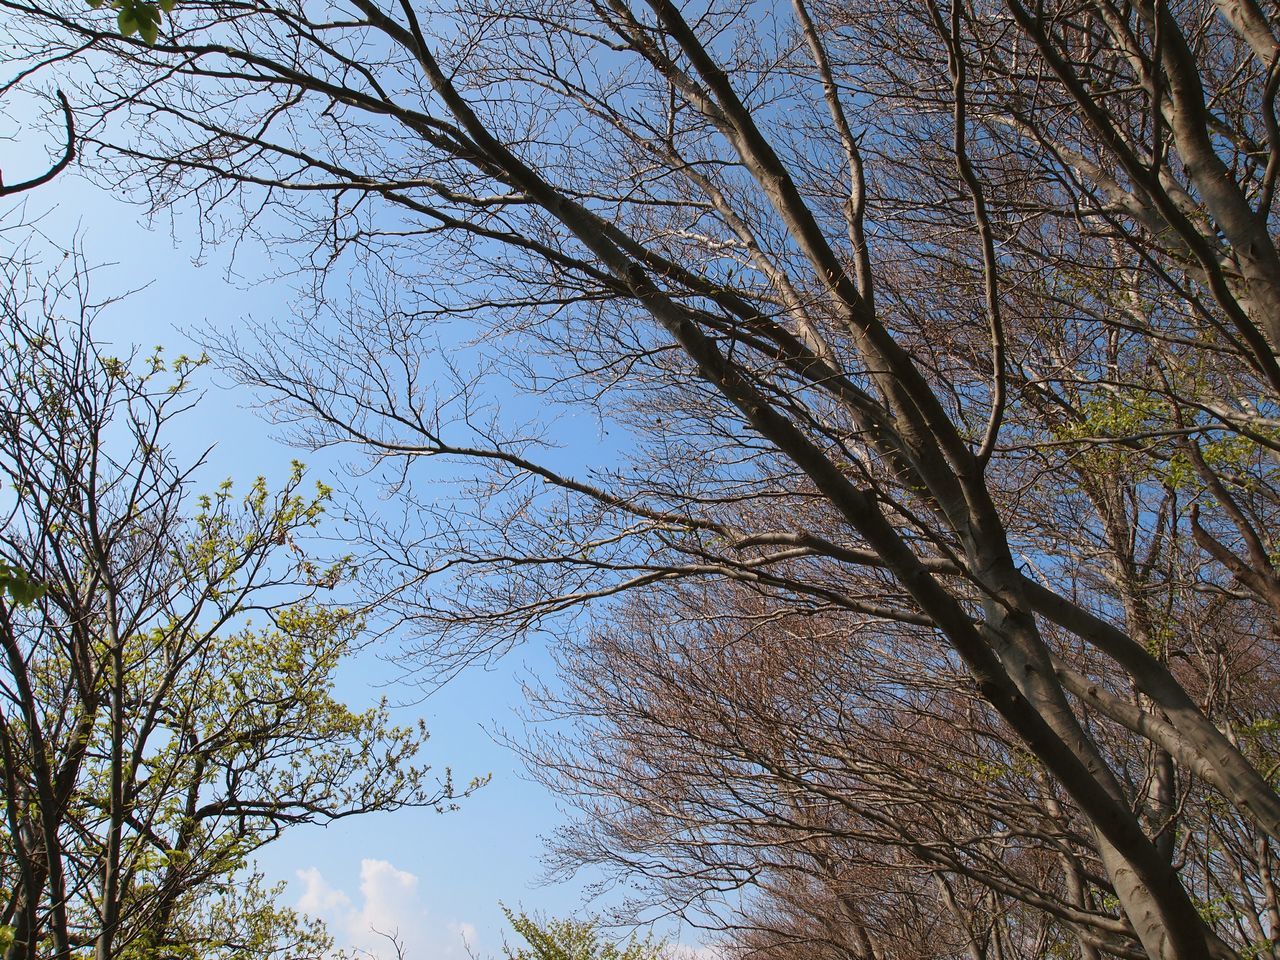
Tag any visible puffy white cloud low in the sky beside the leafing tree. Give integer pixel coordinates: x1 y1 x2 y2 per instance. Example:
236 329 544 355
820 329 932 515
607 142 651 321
297 859 476 960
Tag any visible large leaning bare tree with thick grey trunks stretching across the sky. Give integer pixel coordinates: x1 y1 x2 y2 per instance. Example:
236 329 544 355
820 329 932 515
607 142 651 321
5 0 1280 960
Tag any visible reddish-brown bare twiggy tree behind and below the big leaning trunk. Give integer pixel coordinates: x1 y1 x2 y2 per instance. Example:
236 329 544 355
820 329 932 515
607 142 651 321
522 584 1277 960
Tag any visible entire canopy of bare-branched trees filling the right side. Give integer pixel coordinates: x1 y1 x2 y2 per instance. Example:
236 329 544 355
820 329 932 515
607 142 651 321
0 0 1280 960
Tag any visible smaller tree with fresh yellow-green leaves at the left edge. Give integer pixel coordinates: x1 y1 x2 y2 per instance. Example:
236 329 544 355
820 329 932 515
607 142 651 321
0 235 454 960
